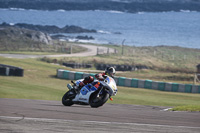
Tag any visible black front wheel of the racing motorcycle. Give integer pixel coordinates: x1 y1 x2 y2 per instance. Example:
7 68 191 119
89 91 109 108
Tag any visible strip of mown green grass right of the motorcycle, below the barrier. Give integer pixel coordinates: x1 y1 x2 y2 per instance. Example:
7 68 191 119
113 87 200 107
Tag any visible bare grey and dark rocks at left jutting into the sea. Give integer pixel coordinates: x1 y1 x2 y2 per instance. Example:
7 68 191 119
0 23 96 44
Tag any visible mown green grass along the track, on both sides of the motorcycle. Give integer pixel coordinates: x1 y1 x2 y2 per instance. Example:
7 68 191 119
0 57 200 110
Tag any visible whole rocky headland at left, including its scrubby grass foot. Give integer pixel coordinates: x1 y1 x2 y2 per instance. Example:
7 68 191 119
0 23 93 54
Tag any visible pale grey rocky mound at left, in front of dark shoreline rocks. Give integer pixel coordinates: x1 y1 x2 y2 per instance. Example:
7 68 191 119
0 27 52 50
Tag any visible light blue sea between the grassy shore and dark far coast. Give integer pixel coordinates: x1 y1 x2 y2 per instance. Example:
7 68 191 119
0 8 200 49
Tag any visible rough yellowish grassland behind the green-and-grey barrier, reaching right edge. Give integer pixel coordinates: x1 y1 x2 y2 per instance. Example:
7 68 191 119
38 45 200 84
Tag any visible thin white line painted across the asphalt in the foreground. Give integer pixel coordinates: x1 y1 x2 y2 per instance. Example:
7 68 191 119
0 116 200 129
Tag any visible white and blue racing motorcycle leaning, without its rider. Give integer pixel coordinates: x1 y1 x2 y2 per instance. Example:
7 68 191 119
62 76 117 108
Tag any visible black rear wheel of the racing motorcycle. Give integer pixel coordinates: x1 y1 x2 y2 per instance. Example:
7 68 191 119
62 91 75 106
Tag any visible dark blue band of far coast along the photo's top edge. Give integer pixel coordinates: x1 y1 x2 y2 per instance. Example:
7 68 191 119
0 0 200 13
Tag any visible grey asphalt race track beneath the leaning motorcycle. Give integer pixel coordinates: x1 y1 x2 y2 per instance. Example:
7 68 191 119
0 98 200 133
